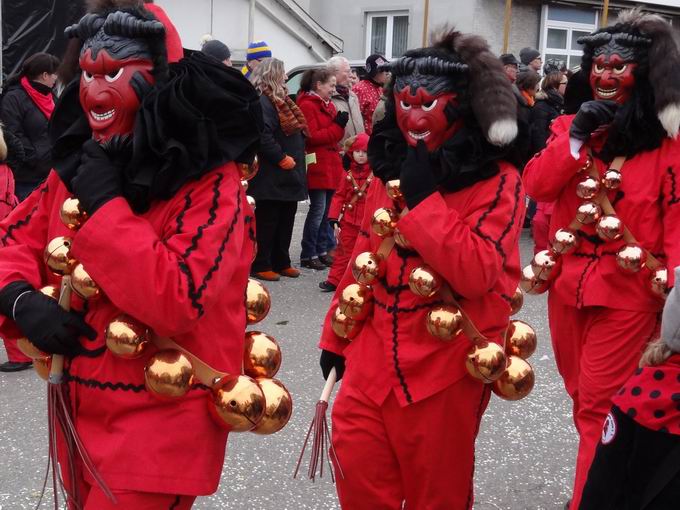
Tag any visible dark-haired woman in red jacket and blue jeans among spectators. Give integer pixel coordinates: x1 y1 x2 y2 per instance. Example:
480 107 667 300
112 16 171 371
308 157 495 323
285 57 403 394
297 68 346 270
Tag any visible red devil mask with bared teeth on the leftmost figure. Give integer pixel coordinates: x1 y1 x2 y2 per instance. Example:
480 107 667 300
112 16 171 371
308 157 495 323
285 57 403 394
80 49 154 142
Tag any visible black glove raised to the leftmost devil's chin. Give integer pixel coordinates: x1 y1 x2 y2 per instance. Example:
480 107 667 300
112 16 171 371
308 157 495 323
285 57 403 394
71 140 123 215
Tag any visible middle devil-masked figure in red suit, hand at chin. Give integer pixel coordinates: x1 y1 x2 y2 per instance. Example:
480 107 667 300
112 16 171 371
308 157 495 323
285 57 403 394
320 32 524 510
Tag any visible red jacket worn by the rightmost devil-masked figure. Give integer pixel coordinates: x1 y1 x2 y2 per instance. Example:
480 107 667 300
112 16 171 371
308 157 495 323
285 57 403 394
524 115 680 312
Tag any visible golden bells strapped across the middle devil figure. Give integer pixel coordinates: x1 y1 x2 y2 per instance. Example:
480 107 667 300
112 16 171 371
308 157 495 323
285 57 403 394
331 180 537 400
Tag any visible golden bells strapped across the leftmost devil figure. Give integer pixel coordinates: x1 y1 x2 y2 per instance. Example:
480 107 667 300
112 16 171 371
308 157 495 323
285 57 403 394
18 183 293 434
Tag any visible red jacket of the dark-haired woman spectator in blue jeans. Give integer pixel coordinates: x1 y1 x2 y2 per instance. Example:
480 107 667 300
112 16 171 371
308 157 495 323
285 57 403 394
297 92 345 190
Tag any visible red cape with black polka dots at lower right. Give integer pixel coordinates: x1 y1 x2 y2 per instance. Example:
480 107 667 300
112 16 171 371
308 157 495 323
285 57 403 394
612 354 680 435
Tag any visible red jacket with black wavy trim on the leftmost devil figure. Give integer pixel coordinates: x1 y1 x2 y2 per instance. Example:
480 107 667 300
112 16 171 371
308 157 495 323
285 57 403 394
0 163 253 495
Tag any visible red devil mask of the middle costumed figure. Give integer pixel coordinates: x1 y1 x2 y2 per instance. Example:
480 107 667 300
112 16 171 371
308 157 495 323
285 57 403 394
394 86 462 152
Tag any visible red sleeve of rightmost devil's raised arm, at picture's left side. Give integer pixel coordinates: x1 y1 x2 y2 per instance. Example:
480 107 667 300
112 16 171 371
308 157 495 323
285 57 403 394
522 116 587 202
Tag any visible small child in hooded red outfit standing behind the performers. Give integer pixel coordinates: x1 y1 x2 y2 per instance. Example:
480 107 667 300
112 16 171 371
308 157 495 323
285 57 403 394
319 133 373 292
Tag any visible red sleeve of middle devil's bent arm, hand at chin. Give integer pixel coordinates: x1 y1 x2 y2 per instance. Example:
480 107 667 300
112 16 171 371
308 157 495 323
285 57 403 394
398 170 524 299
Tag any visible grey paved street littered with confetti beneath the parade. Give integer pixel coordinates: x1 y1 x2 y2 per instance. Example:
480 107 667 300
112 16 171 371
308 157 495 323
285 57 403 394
0 206 576 510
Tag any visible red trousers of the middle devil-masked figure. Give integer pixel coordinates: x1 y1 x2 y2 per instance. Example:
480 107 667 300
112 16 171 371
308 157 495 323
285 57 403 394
333 377 489 510
